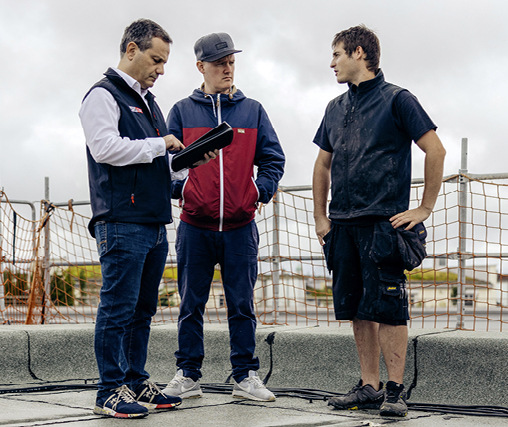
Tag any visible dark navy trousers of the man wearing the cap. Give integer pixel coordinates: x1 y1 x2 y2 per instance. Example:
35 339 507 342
175 221 259 382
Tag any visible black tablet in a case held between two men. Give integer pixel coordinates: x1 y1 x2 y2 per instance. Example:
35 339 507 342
171 122 233 172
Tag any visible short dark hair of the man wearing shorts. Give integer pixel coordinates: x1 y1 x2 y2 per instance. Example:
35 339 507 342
332 24 381 72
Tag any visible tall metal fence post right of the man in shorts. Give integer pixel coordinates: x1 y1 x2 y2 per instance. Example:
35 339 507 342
455 138 469 329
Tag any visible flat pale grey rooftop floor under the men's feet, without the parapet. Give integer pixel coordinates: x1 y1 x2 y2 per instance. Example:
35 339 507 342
0 388 508 427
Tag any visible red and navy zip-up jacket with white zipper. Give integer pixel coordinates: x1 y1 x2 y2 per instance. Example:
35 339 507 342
167 87 285 231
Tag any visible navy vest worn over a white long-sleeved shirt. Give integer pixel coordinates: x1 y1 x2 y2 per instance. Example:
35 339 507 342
85 68 172 236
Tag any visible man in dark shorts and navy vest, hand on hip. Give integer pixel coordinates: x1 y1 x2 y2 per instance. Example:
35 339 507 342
313 25 445 416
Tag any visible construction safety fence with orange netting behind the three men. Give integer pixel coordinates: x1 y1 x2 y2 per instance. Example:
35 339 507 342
0 147 508 331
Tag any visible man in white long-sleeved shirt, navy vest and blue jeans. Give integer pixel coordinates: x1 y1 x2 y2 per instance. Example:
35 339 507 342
79 19 213 418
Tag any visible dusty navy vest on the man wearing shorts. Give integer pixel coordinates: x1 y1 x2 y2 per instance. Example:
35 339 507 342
325 71 412 219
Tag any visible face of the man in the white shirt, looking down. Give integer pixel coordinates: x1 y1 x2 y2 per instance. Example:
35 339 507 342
126 37 169 89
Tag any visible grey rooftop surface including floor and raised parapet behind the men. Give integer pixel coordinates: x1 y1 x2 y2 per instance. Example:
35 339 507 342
0 325 508 427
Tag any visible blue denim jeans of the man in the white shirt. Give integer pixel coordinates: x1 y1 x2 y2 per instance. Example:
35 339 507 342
95 221 168 397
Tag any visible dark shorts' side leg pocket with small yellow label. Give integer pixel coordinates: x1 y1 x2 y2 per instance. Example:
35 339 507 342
376 271 408 320
